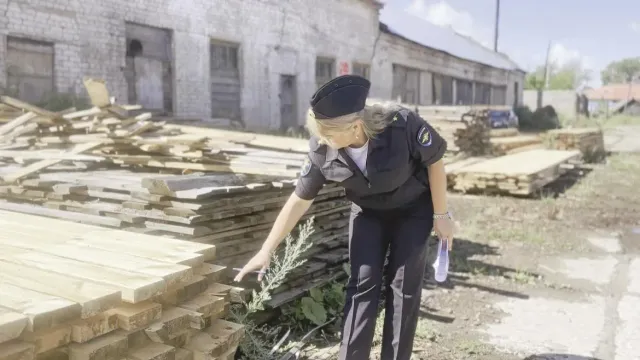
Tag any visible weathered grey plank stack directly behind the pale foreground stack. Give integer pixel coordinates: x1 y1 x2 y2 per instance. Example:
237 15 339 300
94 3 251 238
0 169 349 306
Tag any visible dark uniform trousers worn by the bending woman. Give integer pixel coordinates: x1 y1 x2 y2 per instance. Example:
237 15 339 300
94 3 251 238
338 195 433 360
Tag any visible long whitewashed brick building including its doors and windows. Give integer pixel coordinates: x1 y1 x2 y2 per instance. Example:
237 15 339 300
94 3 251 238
0 0 523 128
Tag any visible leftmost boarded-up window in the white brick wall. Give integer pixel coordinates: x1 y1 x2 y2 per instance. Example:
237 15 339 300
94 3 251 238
6 37 55 104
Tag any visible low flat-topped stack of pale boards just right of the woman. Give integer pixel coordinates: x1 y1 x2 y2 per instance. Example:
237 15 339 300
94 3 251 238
447 149 581 196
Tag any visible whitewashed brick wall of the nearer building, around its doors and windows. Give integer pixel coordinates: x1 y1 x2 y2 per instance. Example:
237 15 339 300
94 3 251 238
0 0 378 128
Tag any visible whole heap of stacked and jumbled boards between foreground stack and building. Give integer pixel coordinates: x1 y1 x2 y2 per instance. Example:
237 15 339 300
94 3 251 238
0 79 348 306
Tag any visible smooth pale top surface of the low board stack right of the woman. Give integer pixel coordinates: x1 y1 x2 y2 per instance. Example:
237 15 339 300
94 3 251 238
457 149 580 176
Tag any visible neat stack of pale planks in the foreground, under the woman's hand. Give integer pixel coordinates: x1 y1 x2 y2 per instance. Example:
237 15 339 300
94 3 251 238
0 211 244 360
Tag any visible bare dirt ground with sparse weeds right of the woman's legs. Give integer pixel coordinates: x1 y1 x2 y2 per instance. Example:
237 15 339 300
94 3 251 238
296 153 640 360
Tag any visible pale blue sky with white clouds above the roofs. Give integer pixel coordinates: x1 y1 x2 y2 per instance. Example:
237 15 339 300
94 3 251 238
384 0 640 86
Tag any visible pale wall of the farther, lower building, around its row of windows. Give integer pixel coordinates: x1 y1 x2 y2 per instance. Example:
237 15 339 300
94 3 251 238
371 33 524 105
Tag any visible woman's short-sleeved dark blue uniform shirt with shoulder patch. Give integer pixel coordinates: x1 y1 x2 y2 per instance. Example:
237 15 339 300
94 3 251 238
295 109 447 209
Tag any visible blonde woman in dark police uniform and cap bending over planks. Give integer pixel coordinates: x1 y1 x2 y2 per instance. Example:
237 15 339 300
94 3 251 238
235 75 454 360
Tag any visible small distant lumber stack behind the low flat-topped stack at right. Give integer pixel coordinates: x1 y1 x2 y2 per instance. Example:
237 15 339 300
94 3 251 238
546 128 606 162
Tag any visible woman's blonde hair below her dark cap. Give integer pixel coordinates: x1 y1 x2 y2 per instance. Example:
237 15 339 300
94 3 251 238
306 104 400 143
